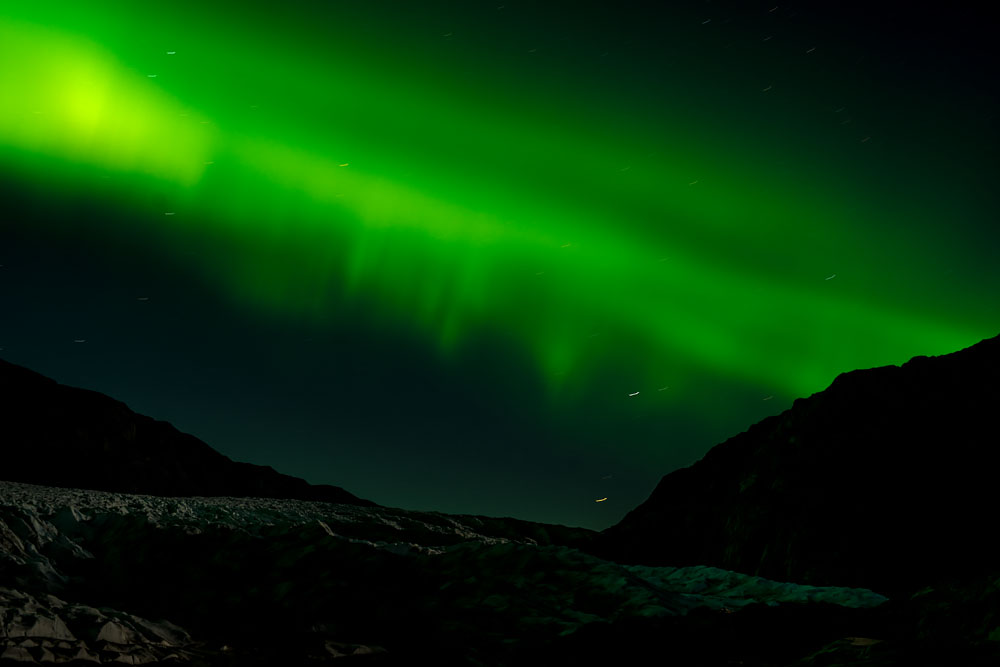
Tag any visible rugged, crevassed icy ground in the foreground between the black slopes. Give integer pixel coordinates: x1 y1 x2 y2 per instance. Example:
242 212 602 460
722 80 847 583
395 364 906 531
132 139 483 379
0 483 885 665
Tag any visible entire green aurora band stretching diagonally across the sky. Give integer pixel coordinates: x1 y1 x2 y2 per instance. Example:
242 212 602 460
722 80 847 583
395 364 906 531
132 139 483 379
0 5 995 414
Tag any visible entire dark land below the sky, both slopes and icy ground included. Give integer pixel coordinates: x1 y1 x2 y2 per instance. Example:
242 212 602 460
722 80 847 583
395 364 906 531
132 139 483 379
0 337 1000 667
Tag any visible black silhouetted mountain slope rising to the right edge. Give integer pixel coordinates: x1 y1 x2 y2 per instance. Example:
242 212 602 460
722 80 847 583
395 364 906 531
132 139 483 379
591 336 1000 595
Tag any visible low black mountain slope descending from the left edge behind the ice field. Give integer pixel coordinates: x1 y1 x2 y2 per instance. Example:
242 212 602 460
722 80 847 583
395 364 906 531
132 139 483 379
0 360 375 506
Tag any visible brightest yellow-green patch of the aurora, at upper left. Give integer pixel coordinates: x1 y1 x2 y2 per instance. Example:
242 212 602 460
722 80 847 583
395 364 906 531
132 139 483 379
0 19 212 186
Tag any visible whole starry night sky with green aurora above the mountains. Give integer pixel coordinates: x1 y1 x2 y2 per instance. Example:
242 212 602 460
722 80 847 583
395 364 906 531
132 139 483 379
0 0 1000 528
